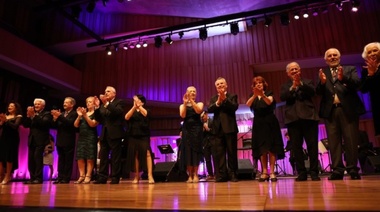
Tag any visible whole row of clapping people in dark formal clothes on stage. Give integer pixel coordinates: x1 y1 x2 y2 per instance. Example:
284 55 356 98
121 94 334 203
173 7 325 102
0 42 380 184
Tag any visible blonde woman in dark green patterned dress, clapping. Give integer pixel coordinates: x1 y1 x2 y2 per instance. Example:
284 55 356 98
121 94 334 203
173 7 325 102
74 96 99 184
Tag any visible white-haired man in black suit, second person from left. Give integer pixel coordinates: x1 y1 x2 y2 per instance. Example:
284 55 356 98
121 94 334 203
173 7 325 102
24 98 53 184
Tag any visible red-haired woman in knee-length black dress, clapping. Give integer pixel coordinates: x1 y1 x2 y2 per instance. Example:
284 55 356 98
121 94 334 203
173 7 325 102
246 76 284 182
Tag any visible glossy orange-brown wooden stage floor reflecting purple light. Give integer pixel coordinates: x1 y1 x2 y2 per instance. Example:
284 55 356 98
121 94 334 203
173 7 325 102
0 175 380 212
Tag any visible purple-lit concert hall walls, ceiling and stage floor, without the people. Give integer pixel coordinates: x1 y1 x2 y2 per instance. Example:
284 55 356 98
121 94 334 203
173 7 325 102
0 0 380 211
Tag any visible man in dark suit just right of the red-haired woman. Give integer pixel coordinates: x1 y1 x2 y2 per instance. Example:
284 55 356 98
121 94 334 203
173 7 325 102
280 62 321 181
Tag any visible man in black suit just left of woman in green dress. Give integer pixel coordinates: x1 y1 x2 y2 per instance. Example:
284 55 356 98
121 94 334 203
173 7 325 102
51 97 78 184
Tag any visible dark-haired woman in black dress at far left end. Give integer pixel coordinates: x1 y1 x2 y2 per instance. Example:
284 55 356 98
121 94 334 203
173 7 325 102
0 102 22 185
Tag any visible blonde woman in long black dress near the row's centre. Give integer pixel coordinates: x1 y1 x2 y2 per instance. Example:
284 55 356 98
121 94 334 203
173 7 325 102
179 86 203 183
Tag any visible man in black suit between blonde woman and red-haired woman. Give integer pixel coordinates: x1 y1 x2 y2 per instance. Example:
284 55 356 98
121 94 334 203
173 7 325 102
208 77 239 182
